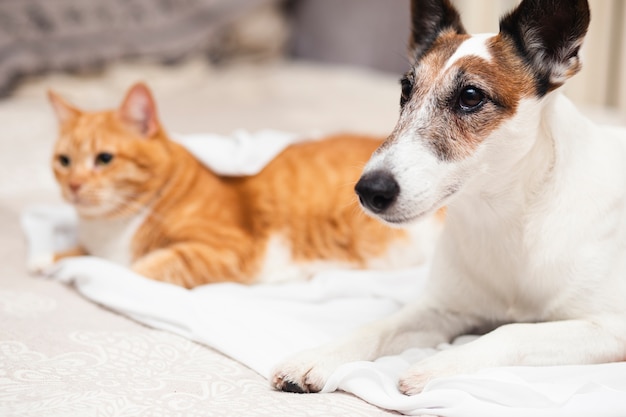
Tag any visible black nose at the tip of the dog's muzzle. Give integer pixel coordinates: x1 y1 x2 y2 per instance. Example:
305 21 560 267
354 171 400 213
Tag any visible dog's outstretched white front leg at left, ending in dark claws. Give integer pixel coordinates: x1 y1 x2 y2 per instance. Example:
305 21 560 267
271 302 478 393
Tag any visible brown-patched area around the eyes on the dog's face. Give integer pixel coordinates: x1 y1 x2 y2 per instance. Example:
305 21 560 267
388 31 537 161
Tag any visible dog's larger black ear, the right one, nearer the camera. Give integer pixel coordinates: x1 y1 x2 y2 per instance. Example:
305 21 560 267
500 0 590 95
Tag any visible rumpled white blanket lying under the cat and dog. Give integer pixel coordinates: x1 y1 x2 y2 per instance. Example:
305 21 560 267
22 133 626 417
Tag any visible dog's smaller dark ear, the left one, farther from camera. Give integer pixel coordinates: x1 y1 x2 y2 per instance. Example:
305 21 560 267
409 0 465 62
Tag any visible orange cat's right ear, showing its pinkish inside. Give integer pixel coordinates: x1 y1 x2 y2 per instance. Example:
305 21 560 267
118 83 159 138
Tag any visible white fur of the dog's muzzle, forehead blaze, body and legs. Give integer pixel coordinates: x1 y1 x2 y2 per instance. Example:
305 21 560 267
272 0 626 394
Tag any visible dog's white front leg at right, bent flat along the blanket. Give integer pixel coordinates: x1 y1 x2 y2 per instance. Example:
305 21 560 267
399 320 626 395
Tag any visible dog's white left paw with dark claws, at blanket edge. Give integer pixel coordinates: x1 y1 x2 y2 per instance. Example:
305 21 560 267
271 350 340 394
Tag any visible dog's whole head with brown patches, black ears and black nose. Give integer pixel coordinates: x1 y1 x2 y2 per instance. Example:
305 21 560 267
356 0 589 225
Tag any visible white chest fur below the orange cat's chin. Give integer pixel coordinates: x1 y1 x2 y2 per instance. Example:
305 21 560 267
78 210 148 266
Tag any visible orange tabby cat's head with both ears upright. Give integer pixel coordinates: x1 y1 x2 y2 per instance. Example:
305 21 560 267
48 83 171 218
